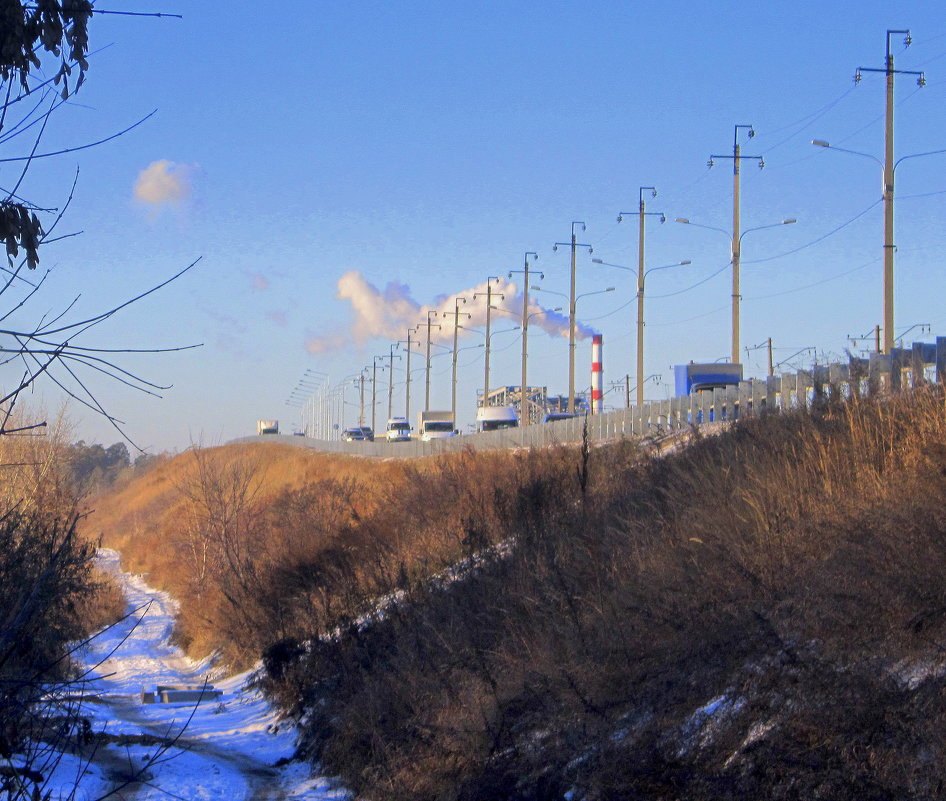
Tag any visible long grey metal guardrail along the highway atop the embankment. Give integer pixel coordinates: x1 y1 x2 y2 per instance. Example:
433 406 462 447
237 337 946 459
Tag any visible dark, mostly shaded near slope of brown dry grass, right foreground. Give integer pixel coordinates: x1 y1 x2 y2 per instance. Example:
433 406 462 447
256 390 946 801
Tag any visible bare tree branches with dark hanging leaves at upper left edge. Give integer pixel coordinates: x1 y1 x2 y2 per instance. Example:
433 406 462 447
0 0 197 450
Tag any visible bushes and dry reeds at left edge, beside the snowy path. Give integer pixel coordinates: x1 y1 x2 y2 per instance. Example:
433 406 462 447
0 410 125 799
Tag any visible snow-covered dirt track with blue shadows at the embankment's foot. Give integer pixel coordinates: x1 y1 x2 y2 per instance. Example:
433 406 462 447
58 550 348 801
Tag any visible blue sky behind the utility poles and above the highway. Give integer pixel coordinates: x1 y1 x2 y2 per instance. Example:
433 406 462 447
8 0 946 450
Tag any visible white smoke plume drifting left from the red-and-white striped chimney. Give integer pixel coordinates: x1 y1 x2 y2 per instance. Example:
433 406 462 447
306 270 595 353
